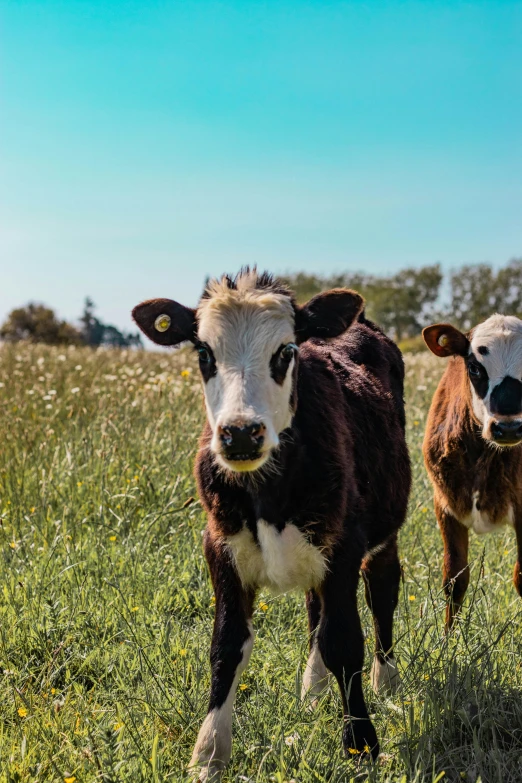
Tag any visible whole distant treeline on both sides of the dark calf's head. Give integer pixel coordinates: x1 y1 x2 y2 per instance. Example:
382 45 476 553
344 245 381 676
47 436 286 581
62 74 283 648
5 258 522 348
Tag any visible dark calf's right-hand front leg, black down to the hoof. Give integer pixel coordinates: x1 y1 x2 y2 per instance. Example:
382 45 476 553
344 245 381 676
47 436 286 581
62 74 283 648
317 547 379 758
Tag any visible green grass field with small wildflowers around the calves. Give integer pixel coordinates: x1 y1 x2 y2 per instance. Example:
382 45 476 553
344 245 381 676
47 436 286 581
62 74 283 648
0 346 522 783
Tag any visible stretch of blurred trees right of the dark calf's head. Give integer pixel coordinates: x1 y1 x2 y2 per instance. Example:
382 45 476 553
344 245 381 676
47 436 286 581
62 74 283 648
284 259 522 342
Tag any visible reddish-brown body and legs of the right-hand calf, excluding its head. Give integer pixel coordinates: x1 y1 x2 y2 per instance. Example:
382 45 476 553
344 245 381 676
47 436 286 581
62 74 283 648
423 318 522 628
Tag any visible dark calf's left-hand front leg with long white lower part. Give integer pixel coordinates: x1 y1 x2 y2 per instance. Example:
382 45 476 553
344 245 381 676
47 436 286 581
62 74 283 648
189 533 254 783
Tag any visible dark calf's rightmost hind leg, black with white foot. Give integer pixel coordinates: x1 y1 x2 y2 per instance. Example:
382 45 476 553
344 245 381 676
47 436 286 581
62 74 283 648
362 533 401 693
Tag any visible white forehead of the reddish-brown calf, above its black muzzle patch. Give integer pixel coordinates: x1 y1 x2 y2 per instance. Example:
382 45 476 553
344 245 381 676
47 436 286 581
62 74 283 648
470 314 522 388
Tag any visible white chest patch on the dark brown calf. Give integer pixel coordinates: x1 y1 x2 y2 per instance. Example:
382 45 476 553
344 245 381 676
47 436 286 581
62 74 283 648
226 519 326 593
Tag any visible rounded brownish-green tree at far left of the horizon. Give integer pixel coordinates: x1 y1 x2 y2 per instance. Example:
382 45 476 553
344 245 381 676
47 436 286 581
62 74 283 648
0 302 82 345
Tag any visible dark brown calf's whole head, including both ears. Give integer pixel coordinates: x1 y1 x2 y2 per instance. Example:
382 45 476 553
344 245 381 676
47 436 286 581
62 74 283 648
132 269 363 472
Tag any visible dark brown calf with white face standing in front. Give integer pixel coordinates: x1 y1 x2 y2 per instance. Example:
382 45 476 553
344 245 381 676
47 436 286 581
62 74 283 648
133 269 410 780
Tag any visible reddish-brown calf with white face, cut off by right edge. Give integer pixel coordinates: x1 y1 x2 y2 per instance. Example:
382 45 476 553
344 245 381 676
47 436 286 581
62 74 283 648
423 315 522 629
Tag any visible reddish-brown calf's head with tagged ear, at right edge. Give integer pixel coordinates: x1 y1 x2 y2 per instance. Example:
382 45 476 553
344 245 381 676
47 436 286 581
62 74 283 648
423 315 522 446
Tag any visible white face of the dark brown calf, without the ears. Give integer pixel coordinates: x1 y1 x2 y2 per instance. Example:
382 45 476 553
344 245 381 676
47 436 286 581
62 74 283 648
196 280 297 472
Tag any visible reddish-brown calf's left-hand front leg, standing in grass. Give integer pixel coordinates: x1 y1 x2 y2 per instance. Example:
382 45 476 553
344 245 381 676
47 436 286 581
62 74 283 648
435 503 469 631
